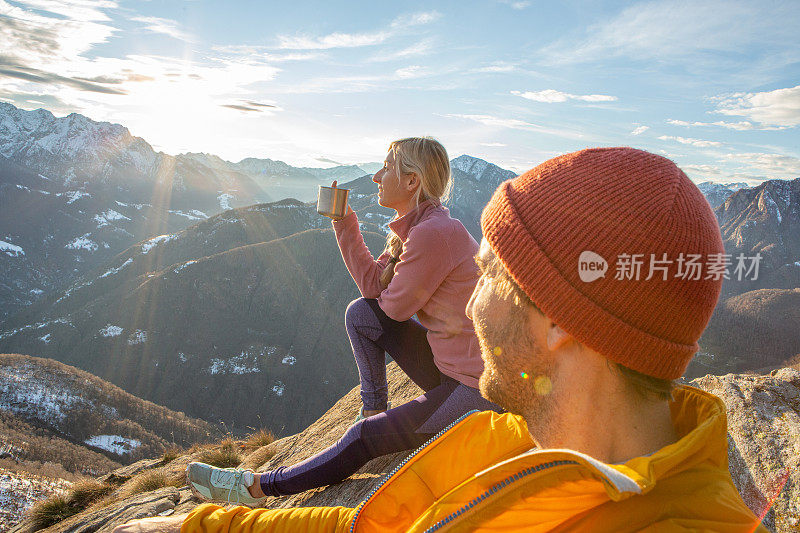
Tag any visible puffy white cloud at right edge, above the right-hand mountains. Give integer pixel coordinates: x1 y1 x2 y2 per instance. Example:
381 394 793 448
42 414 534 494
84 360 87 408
716 85 800 127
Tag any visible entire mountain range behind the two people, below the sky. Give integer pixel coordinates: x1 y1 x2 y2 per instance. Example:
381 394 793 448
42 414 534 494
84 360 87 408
0 104 800 434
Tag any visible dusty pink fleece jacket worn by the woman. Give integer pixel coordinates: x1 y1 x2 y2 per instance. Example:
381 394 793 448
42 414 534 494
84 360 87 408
333 200 483 388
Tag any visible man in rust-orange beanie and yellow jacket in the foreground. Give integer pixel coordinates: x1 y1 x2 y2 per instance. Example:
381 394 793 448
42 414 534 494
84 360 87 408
112 148 763 532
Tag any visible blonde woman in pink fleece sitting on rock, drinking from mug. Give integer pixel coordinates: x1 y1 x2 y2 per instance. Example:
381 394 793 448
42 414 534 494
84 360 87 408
187 137 502 507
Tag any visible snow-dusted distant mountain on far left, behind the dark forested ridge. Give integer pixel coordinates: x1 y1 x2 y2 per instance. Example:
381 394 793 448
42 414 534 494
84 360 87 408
0 102 374 323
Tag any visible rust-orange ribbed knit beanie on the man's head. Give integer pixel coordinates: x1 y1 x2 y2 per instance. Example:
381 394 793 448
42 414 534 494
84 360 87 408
481 148 724 379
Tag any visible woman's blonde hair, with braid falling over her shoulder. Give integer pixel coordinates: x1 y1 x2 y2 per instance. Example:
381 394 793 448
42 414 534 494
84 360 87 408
380 137 453 289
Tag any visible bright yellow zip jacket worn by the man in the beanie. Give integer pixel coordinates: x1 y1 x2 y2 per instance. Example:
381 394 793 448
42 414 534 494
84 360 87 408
181 387 766 533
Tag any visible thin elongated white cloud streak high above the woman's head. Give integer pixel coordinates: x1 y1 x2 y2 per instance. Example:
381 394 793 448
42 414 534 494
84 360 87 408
278 11 441 50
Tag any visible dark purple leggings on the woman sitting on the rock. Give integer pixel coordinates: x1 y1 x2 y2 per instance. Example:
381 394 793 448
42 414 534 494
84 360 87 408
261 298 502 496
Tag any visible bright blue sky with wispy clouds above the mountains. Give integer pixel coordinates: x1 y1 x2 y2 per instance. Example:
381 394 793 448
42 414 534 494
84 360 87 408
0 0 800 185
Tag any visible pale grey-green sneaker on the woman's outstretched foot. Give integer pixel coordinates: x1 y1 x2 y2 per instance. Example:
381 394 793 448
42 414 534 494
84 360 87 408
186 463 267 507
